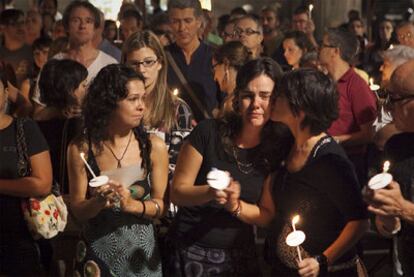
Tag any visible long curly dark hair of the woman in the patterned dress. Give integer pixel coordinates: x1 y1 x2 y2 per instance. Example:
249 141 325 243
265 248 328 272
83 64 151 172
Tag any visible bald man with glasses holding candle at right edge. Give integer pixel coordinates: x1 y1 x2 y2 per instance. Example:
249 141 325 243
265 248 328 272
366 59 414 276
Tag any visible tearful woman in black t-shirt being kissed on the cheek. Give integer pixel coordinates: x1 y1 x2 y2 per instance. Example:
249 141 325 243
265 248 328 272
163 58 289 276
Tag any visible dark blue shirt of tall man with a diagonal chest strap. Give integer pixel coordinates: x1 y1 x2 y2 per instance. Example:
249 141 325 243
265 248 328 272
166 42 219 122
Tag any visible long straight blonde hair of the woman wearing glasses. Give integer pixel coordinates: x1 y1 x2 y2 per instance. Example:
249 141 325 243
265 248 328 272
122 31 176 131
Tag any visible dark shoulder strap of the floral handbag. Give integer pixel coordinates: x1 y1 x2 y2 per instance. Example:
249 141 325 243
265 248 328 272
15 118 31 177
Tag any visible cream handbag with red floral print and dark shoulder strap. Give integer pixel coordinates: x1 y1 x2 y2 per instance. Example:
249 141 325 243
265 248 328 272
16 118 68 239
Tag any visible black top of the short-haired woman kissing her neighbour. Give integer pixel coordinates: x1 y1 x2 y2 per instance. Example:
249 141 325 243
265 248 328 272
267 136 368 268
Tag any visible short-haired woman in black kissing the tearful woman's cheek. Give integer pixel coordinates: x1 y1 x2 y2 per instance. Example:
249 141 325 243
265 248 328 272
267 69 368 276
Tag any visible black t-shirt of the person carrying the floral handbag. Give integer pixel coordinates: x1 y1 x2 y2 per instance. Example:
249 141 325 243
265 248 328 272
0 119 48 240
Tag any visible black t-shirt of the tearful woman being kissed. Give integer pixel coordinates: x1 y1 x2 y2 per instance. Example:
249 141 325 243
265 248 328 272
170 120 266 248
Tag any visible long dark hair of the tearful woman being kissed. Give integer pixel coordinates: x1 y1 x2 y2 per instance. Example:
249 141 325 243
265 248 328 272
218 57 290 173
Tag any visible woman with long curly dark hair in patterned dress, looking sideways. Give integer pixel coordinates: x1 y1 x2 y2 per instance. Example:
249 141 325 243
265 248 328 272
68 64 168 276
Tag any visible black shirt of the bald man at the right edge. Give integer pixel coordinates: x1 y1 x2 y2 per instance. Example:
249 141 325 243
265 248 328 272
384 133 414 276
